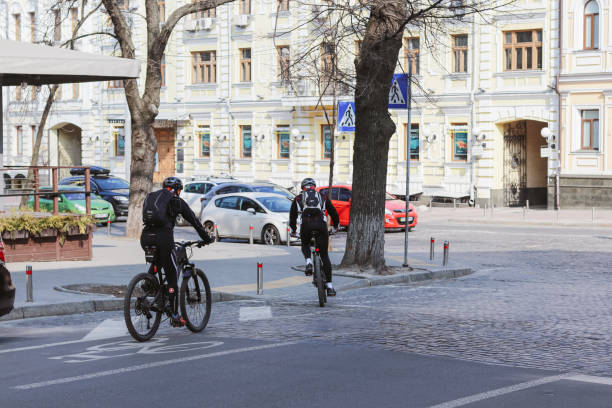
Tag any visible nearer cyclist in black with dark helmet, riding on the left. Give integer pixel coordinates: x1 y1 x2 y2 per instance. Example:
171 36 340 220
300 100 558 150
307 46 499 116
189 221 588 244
140 177 213 326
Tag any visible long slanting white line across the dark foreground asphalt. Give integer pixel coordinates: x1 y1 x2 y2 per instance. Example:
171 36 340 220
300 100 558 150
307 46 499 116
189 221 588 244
12 341 299 390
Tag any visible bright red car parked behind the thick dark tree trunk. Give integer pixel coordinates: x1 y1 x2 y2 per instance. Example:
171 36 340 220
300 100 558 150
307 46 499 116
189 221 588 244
317 185 419 230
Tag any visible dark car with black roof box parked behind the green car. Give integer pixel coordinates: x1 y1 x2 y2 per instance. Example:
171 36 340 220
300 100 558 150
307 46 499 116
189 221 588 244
60 166 130 217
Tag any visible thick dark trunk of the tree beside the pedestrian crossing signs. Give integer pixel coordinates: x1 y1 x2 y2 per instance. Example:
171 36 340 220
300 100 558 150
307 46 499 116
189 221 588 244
342 0 406 273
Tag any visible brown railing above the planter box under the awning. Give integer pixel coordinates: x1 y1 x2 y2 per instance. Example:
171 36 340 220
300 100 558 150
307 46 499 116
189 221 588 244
0 166 91 215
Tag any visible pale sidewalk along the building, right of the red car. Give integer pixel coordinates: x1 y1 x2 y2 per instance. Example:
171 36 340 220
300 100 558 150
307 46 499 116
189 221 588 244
416 206 612 228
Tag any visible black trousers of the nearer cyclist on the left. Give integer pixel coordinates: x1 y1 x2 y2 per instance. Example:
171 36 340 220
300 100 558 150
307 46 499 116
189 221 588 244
140 228 178 313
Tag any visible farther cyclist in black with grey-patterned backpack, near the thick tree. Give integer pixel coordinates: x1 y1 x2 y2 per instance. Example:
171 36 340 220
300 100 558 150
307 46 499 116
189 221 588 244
289 178 340 296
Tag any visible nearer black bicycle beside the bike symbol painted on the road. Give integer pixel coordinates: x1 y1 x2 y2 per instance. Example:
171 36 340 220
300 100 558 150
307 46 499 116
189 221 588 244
123 241 212 341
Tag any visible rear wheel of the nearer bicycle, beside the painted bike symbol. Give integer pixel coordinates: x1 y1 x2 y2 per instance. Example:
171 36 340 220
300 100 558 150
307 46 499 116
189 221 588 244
123 273 162 341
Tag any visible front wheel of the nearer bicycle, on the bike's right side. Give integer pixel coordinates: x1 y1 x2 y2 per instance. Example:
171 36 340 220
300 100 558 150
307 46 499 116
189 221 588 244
179 269 212 333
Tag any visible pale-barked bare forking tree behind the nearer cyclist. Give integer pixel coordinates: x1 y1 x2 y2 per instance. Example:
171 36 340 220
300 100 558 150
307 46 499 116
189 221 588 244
102 0 232 237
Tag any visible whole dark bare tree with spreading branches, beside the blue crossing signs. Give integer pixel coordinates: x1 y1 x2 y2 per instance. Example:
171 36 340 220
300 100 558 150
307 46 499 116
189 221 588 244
278 0 513 273
